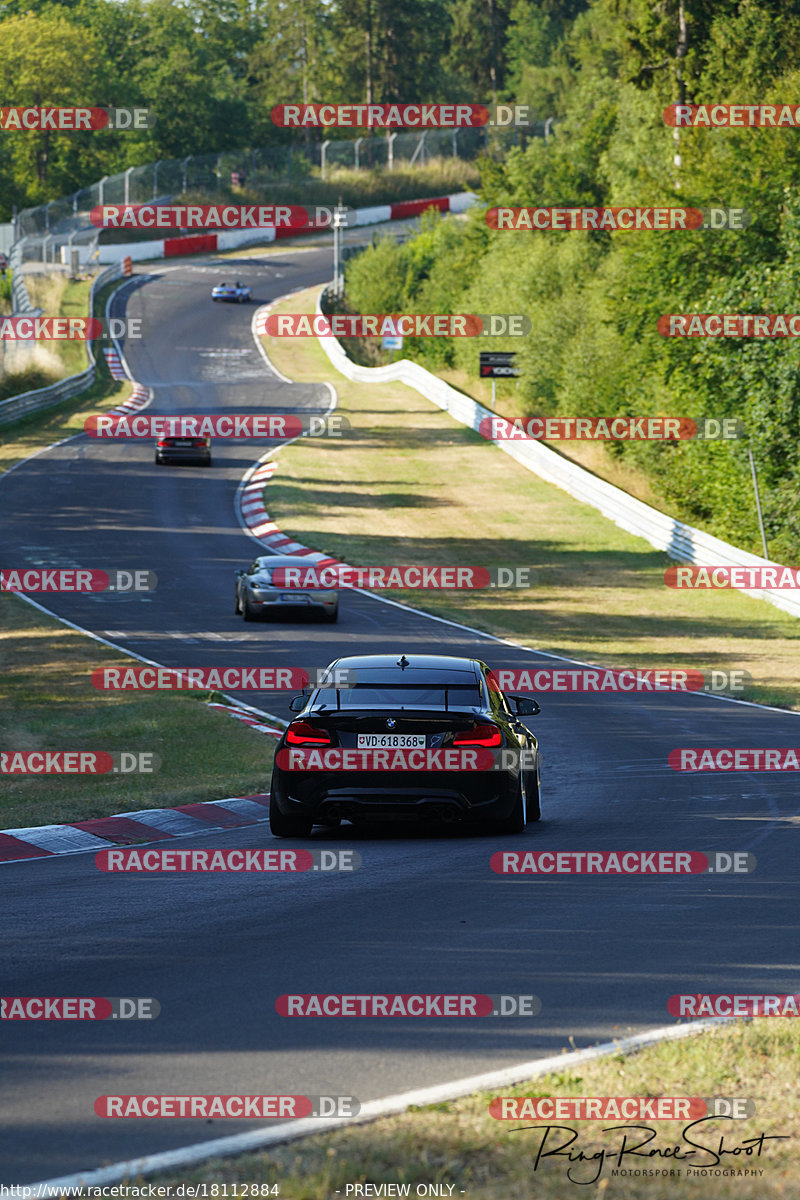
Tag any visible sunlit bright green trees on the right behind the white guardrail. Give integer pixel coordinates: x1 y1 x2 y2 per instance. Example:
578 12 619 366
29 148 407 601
348 0 800 563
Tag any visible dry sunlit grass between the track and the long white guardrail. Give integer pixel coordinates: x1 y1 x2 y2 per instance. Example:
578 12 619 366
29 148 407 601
263 288 800 708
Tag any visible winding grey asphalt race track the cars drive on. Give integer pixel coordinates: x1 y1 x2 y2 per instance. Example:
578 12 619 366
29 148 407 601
0 250 798 1183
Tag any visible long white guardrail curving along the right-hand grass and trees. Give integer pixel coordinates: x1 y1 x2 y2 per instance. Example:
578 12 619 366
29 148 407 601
317 283 800 617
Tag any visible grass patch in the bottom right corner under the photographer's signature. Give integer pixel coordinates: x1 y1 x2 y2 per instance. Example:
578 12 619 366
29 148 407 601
149 1018 800 1200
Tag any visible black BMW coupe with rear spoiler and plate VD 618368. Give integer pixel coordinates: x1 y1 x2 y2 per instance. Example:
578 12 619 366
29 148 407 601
270 654 540 838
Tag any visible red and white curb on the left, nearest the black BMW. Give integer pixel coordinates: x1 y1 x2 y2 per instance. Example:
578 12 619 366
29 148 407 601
0 792 270 863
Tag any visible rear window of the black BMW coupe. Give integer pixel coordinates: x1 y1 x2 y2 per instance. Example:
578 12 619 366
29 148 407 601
314 668 482 709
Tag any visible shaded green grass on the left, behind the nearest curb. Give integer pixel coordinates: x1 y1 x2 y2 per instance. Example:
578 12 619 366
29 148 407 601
0 593 276 829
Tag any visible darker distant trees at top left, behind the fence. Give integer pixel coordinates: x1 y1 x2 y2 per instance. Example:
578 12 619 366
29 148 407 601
0 0 551 214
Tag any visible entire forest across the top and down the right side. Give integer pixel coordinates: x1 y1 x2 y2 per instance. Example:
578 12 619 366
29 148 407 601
0 0 800 562
